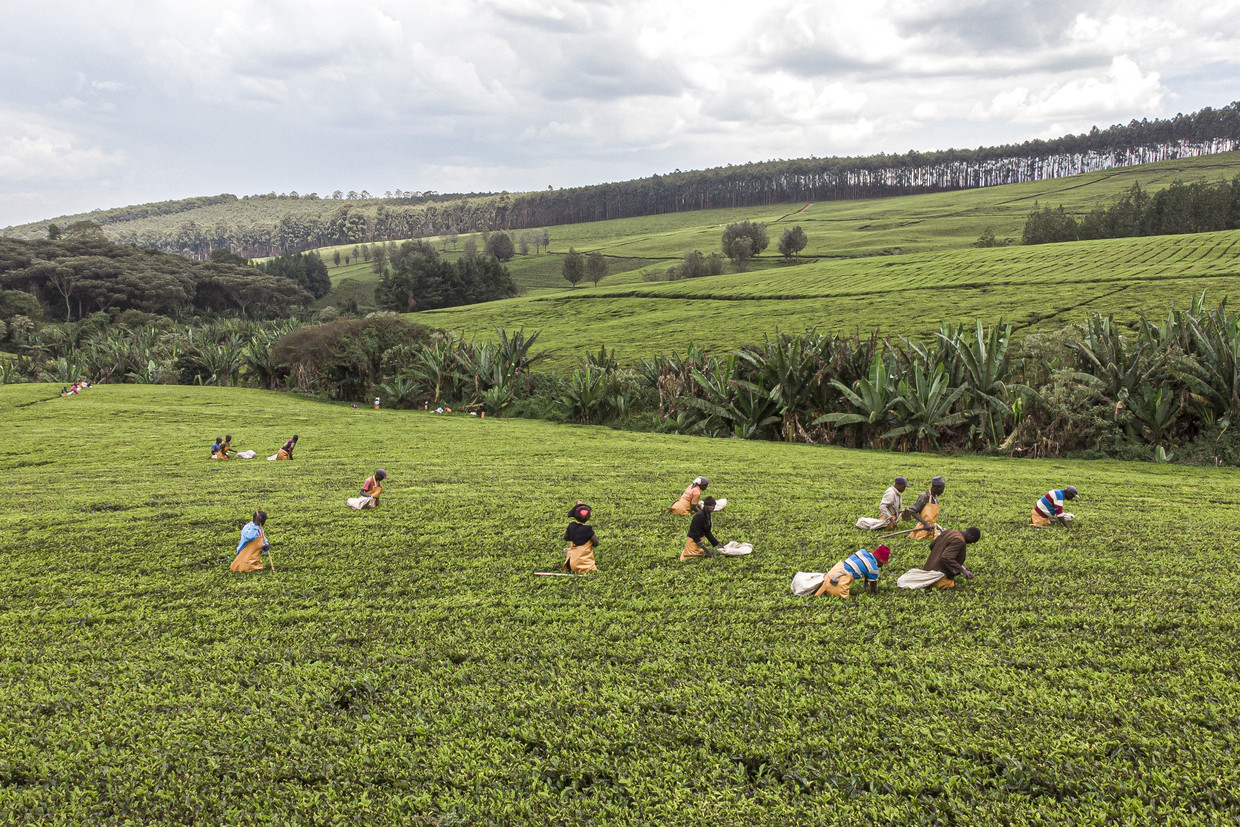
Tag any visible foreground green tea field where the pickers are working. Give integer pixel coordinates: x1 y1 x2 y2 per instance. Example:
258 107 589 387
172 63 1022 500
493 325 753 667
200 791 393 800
0 386 1240 825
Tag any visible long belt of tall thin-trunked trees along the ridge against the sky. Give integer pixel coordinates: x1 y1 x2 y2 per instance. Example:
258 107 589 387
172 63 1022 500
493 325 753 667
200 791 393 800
10 102 1240 259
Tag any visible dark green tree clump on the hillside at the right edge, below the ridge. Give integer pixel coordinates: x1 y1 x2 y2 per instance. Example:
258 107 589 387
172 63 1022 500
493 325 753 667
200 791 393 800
1021 176 1240 244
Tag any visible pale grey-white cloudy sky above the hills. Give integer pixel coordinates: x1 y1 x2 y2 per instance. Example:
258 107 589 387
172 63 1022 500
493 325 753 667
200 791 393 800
0 0 1240 226
